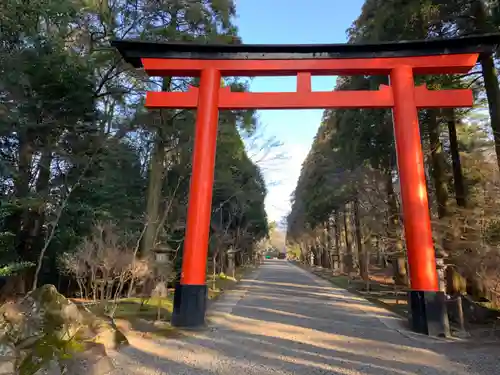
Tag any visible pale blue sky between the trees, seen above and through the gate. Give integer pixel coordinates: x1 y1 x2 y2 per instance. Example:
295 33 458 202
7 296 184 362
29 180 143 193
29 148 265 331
236 0 364 226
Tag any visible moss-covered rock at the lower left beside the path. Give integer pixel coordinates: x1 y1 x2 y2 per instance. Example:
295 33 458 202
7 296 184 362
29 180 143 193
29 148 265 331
0 285 127 375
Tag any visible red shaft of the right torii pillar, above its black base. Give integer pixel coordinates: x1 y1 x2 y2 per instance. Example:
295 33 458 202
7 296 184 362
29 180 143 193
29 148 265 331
390 66 438 292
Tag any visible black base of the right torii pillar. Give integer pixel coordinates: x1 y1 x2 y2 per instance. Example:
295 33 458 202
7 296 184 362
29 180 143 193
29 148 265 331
408 290 450 337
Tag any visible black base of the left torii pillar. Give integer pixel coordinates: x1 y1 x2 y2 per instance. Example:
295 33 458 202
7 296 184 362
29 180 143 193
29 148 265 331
171 284 208 328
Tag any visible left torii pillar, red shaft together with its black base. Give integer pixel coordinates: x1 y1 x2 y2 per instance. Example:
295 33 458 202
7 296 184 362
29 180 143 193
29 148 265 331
172 68 221 327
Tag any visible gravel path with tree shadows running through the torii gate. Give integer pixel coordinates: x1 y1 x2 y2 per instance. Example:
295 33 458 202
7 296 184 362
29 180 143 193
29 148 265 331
108 260 500 375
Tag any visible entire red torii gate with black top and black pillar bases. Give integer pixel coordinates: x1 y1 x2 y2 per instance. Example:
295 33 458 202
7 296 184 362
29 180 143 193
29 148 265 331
112 34 499 334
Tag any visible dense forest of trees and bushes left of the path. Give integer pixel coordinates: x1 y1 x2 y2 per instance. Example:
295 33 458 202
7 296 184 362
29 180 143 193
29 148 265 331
0 0 268 297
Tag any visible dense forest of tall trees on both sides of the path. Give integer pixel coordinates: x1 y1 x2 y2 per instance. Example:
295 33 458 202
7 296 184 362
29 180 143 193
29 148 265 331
0 0 500 312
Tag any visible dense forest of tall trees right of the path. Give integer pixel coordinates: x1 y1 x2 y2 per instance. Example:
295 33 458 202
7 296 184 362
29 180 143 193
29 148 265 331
287 0 500 305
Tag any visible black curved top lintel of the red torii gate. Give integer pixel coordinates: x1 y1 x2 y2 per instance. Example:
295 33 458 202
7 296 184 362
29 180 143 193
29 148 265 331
111 33 500 68
